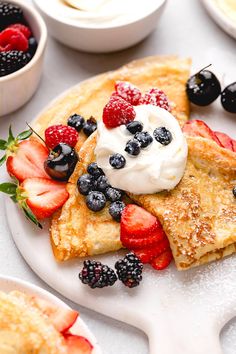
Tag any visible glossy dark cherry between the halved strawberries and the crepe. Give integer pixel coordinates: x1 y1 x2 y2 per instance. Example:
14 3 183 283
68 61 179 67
44 143 79 181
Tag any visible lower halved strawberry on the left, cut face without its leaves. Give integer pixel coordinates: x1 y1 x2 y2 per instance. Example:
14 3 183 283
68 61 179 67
20 178 69 219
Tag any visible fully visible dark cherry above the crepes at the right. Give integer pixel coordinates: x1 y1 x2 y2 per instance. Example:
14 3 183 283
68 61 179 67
186 65 221 106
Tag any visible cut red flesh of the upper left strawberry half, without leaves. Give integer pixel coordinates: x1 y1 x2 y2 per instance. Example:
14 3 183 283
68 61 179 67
6 137 50 182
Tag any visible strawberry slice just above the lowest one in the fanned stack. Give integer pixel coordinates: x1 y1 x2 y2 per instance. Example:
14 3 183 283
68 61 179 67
133 236 170 264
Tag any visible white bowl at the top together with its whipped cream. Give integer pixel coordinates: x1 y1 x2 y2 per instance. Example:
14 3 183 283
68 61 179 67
33 0 166 53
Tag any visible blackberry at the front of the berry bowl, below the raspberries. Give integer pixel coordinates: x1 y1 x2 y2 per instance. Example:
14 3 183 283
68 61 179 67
0 50 30 77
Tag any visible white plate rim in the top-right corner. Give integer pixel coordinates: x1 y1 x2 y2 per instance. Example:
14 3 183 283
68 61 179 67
202 0 236 38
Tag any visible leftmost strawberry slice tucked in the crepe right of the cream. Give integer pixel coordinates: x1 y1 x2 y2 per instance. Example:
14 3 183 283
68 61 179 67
183 119 222 146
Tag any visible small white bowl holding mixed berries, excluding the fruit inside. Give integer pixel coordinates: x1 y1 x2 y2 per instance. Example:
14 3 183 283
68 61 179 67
0 0 47 117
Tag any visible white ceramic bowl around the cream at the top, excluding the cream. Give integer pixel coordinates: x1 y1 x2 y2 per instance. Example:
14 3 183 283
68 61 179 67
33 0 166 53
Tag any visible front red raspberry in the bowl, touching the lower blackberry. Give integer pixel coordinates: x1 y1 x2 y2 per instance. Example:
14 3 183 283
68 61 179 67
0 28 28 52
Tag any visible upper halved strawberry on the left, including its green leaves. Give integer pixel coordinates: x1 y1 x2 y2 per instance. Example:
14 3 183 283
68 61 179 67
0 127 49 182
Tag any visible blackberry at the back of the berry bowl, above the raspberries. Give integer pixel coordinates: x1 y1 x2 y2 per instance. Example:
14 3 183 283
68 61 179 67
0 1 24 30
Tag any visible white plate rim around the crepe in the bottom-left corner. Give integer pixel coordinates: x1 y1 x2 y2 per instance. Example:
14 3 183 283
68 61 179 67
0 275 101 354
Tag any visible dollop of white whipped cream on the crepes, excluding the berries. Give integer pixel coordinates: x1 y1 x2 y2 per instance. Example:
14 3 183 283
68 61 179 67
95 105 188 194
